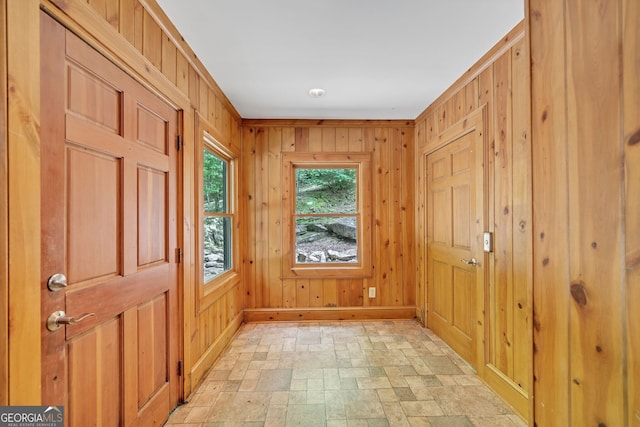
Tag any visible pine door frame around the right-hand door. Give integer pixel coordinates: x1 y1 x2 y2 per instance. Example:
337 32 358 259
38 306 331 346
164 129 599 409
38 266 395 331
418 105 491 377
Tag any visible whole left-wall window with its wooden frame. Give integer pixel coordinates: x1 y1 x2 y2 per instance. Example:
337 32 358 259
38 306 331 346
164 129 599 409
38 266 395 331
195 125 239 310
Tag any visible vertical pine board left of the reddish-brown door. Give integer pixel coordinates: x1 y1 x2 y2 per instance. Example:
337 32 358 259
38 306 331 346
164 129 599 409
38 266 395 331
2 0 41 405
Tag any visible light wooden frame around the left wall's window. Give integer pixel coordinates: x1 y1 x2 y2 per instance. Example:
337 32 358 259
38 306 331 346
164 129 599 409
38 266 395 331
194 119 240 312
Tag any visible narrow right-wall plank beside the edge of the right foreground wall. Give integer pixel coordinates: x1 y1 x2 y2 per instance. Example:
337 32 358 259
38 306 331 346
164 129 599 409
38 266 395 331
511 39 533 393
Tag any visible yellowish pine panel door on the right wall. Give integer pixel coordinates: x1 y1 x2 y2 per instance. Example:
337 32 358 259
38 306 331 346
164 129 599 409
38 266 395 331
426 114 484 367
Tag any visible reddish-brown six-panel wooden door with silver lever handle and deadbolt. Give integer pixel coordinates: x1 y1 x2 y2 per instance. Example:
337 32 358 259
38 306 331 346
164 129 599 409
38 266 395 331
40 13 180 427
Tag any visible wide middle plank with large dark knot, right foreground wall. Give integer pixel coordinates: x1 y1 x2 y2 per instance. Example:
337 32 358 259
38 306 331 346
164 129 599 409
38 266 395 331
565 0 624 426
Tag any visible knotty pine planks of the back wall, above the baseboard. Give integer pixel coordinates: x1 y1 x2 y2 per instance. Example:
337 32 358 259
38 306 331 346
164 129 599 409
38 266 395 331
241 120 415 309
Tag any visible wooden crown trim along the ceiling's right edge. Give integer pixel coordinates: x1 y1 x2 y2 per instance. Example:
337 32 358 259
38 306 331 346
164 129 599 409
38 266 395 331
415 20 525 122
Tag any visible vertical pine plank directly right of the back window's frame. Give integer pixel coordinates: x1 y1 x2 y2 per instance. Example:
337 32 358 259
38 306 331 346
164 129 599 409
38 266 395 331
370 128 391 306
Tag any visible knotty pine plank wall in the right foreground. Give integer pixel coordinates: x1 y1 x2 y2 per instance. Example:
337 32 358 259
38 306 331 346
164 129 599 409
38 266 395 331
527 0 640 426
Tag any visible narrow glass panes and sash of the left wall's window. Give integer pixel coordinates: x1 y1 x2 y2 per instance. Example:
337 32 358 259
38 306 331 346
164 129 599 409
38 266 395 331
202 140 233 284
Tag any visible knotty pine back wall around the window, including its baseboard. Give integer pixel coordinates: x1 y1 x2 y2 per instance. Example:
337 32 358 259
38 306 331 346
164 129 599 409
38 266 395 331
241 120 415 320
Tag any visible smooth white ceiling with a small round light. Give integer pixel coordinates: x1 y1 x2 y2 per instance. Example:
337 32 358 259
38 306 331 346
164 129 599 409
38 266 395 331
157 0 524 120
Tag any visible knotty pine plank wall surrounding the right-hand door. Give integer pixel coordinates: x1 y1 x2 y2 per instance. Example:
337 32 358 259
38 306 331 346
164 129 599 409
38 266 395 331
416 23 533 417
